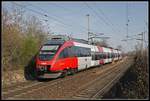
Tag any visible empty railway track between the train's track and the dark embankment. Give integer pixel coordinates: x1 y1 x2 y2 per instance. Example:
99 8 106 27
73 56 133 99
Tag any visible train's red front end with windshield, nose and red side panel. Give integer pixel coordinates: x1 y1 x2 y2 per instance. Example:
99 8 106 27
36 42 76 78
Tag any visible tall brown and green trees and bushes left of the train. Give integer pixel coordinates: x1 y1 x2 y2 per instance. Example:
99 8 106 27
1 8 47 71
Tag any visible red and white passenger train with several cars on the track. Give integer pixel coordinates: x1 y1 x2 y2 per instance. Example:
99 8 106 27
36 40 122 78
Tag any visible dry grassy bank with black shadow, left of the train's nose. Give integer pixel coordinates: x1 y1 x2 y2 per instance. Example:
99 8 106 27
2 58 36 88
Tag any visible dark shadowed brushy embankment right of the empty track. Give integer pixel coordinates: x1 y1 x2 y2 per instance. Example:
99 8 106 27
103 51 149 99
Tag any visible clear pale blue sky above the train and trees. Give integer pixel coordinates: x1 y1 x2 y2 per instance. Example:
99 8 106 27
2 1 148 52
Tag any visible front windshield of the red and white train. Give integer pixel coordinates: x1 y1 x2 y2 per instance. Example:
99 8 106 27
39 45 60 60
